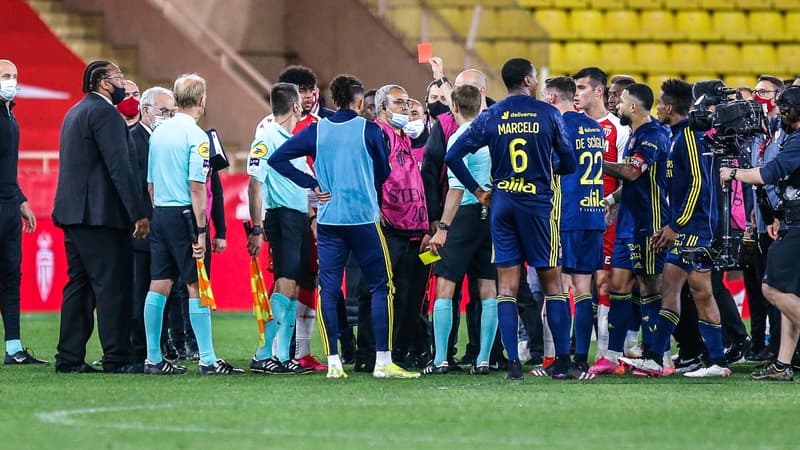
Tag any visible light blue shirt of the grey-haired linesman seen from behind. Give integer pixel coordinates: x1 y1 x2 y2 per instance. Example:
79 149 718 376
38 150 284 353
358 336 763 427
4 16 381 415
147 113 209 206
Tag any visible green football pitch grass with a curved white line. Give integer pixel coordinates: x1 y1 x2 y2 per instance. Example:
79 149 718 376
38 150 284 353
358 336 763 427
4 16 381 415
0 313 800 450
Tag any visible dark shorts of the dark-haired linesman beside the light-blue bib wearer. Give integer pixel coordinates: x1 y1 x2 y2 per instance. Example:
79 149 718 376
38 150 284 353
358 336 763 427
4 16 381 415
264 208 314 289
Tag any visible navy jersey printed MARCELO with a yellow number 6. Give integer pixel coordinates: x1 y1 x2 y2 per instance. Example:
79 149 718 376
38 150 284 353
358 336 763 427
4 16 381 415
445 95 575 217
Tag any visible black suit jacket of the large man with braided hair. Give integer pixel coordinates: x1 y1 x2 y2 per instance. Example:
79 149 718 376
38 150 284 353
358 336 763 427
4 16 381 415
53 93 147 230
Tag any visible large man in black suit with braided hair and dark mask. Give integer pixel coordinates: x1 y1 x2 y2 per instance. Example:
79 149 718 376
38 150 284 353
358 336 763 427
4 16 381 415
53 61 149 372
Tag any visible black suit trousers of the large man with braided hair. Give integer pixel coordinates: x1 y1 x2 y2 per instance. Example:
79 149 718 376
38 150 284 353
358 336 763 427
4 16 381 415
56 225 133 371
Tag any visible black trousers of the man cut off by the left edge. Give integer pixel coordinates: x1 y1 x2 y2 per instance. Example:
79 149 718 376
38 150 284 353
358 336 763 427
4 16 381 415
0 202 22 341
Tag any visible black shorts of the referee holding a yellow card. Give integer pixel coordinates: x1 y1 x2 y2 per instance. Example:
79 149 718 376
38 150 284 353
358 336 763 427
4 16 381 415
433 204 497 283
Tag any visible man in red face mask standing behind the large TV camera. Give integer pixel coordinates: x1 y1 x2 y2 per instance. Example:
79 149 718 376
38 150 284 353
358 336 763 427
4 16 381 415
742 75 786 361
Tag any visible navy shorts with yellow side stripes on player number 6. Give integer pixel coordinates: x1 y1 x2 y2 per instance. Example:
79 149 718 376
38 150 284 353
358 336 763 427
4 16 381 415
490 192 561 269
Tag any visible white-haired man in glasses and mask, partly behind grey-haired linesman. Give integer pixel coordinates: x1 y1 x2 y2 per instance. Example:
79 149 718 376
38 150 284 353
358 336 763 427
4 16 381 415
130 86 178 364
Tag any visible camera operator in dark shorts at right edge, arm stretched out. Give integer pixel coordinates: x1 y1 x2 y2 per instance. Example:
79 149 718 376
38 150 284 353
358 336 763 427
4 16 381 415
720 86 800 381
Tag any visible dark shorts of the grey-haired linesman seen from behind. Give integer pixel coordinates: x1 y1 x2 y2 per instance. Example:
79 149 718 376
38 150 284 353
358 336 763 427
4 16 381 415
150 206 199 284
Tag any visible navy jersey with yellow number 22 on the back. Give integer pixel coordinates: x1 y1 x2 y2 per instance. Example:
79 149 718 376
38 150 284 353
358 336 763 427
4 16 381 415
561 111 606 231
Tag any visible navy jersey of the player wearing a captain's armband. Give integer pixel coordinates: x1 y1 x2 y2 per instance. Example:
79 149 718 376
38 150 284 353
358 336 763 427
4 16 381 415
617 120 670 237
